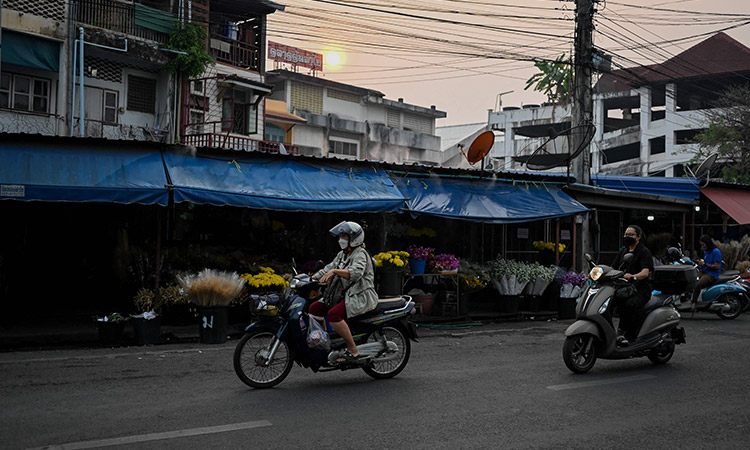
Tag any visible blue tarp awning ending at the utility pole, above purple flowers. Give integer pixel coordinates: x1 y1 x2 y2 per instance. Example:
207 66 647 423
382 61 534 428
394 177 588 223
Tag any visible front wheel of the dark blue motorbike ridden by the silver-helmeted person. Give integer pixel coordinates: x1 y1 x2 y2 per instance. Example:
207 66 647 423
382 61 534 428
234 330 294 389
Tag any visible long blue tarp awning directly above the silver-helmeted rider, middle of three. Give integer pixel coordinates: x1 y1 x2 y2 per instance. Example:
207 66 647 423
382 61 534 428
164 152 405 212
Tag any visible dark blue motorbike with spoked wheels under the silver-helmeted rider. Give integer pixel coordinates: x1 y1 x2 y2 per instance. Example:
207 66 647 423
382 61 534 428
234 266 417 389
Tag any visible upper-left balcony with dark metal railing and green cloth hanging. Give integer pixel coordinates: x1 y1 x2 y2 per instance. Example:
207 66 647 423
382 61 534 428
71 0 176 44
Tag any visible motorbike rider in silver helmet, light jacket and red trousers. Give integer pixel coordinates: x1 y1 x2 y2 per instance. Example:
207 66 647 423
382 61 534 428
309 221 378 362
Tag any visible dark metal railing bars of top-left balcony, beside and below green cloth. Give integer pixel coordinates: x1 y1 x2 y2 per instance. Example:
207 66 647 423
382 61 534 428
72 0 169 43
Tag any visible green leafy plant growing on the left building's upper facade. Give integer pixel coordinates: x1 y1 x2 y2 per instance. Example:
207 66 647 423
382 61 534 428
167 21 214 78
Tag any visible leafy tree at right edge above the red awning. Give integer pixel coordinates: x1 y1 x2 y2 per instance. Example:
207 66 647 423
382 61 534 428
692 84 750 183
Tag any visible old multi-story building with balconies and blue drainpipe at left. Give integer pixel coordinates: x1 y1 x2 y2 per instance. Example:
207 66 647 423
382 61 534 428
0 0 283 149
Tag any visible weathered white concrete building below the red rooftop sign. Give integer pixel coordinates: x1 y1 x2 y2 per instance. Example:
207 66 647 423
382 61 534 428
267 70 446 164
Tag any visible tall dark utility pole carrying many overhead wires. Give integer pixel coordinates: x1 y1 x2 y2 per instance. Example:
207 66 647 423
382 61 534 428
571 0 595 269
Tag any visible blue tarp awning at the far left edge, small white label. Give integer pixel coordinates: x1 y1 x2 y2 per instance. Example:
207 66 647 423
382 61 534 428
0 144 169 205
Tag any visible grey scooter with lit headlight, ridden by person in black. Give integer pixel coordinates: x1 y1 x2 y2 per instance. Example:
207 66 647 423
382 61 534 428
562 254 696 373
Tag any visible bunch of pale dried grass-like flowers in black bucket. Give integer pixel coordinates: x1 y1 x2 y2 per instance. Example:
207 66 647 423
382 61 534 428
177 269 245 306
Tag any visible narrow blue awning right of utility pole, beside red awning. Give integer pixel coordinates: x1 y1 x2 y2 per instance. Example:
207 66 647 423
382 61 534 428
591 175 701 200
